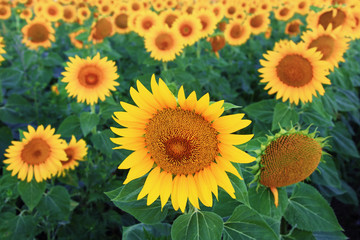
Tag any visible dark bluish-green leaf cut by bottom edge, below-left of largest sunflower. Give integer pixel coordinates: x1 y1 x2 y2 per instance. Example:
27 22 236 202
122 223 171 240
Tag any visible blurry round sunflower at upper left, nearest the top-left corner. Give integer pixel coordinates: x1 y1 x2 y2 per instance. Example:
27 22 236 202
21 18 55 50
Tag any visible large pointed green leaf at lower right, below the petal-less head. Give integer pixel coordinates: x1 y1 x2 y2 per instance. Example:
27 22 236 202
284 183 342 232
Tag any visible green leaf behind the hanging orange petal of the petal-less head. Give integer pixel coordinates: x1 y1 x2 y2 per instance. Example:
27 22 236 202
249 186 288 220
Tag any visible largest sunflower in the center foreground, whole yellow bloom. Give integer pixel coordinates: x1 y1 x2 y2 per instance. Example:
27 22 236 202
111 75 255 212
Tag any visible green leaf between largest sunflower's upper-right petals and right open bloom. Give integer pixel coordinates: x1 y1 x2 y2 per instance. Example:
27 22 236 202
244 99 276 123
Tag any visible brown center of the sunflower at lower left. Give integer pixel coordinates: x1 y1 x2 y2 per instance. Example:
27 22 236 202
21 138 51 165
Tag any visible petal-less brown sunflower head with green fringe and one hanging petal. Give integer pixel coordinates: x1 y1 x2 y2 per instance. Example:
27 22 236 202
253 128 327 207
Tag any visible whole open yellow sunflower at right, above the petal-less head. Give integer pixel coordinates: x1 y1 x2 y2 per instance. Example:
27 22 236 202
259 42 331 105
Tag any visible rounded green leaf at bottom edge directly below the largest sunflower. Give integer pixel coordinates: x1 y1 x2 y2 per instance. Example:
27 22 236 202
171 211 224 240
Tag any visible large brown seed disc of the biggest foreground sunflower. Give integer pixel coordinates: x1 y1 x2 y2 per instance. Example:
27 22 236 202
145 108 219 175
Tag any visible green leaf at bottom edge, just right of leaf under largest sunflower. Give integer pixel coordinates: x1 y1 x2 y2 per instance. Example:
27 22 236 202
223 205 279 240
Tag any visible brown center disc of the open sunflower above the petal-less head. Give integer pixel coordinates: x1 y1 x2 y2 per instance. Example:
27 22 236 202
276 54 313 87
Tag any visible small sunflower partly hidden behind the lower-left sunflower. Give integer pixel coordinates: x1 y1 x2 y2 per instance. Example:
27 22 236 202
57 136 87 176
